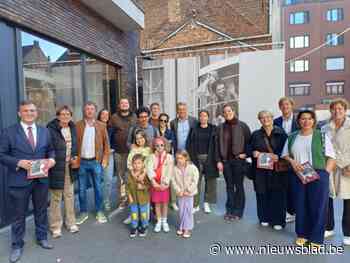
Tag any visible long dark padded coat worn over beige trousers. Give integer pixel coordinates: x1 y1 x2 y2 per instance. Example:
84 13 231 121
47 119 78 190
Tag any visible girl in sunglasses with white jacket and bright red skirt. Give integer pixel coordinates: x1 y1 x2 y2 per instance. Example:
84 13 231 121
146 137 174 233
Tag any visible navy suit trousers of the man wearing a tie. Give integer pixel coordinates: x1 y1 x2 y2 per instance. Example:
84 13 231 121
9 180 48 249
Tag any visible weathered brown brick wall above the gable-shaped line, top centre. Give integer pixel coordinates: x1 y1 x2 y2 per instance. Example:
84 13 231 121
141 0 269 49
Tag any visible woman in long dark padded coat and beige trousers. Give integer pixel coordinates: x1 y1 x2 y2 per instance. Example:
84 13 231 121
47 106 79 238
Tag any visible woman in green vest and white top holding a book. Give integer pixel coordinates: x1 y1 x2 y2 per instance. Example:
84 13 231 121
282 110 335 247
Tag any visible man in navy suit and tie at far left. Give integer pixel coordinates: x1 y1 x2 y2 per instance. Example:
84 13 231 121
0 101 55 262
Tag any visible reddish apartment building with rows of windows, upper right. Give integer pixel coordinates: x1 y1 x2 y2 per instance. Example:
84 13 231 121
282 0 350 109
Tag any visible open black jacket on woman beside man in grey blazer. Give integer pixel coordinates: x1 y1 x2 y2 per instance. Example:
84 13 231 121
186 124 219 177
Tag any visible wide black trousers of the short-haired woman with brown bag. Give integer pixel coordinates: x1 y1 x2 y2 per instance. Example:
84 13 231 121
256 190 287 227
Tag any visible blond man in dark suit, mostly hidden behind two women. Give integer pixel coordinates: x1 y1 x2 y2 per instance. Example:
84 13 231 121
273 97 298 223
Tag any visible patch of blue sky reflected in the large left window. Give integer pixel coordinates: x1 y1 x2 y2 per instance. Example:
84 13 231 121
21 32 67 62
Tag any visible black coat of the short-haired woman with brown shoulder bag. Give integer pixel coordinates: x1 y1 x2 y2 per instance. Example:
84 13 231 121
249 126 288 193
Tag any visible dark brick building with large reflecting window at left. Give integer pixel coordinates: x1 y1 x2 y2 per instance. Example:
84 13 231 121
0 0 144 226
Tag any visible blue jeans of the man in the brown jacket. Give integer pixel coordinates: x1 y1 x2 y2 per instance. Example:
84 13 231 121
79 159 103 213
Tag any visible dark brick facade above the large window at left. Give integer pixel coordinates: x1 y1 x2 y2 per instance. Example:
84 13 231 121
0 0 139 106
